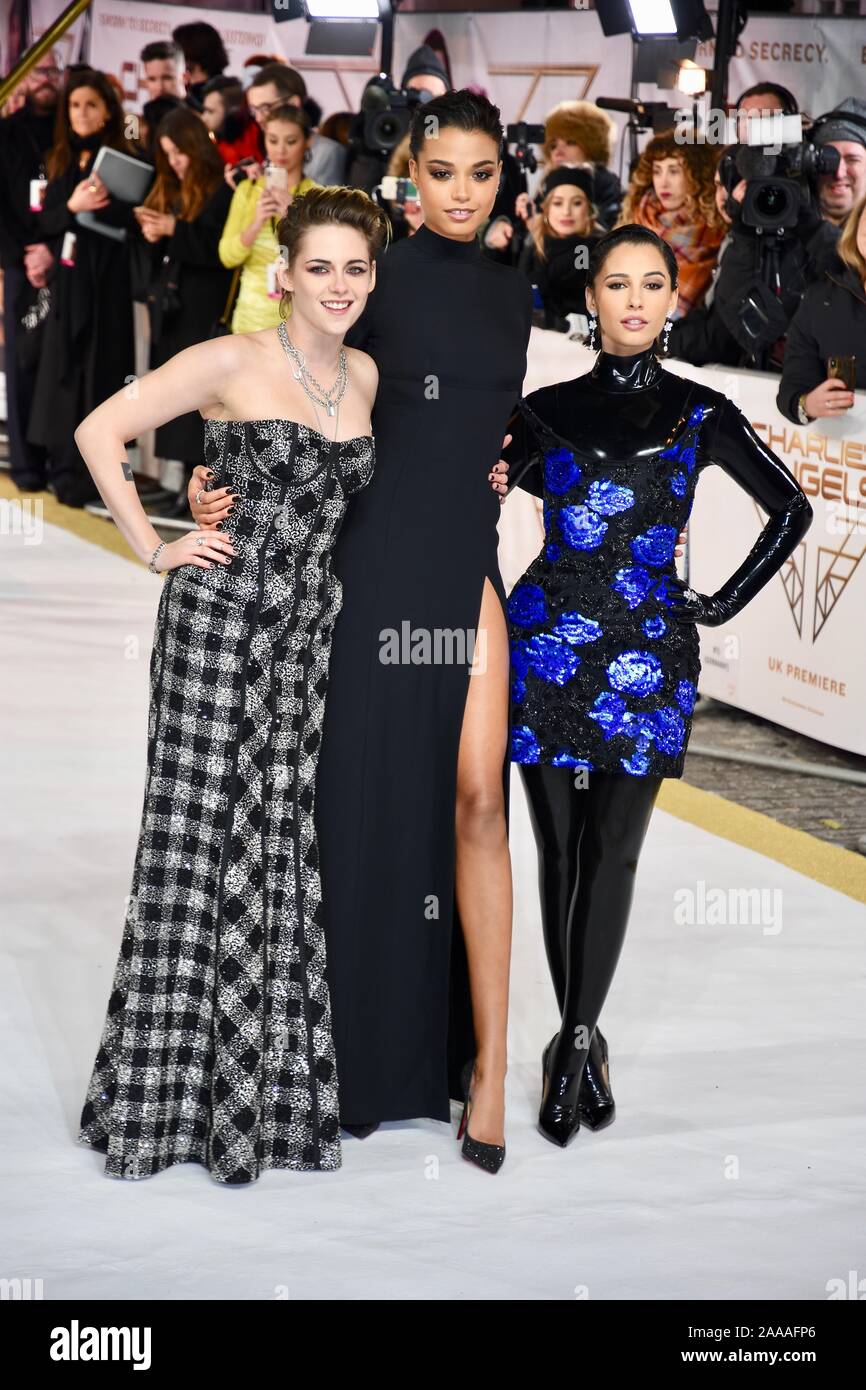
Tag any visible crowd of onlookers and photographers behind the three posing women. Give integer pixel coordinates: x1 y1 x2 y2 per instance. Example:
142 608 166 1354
0 21 866 514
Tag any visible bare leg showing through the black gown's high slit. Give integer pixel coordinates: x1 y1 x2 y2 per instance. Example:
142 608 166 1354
455 577 512 1144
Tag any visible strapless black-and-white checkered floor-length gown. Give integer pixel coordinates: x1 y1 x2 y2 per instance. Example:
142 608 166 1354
79 420 374 1183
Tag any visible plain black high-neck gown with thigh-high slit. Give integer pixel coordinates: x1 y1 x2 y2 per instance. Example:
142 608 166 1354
317 227 532 1123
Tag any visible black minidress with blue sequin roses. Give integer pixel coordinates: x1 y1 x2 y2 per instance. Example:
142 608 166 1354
509 402 708 777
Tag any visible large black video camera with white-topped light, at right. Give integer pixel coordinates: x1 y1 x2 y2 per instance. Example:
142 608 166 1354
719 114 840 236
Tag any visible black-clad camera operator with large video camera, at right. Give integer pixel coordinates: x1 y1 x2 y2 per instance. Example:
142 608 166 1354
713 111 840 371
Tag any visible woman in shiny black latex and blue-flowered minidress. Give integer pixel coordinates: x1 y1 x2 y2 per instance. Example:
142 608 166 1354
506 225 812 1147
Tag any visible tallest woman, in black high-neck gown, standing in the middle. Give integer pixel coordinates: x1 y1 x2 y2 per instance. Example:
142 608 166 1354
190 92 532 1156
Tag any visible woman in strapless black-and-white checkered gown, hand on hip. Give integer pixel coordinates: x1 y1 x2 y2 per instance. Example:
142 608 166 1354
76 189 386 1183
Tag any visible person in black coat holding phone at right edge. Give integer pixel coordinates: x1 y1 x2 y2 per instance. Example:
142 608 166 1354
776 196 866 425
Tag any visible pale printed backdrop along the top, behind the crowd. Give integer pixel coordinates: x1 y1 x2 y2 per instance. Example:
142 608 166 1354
15 0 866 152
